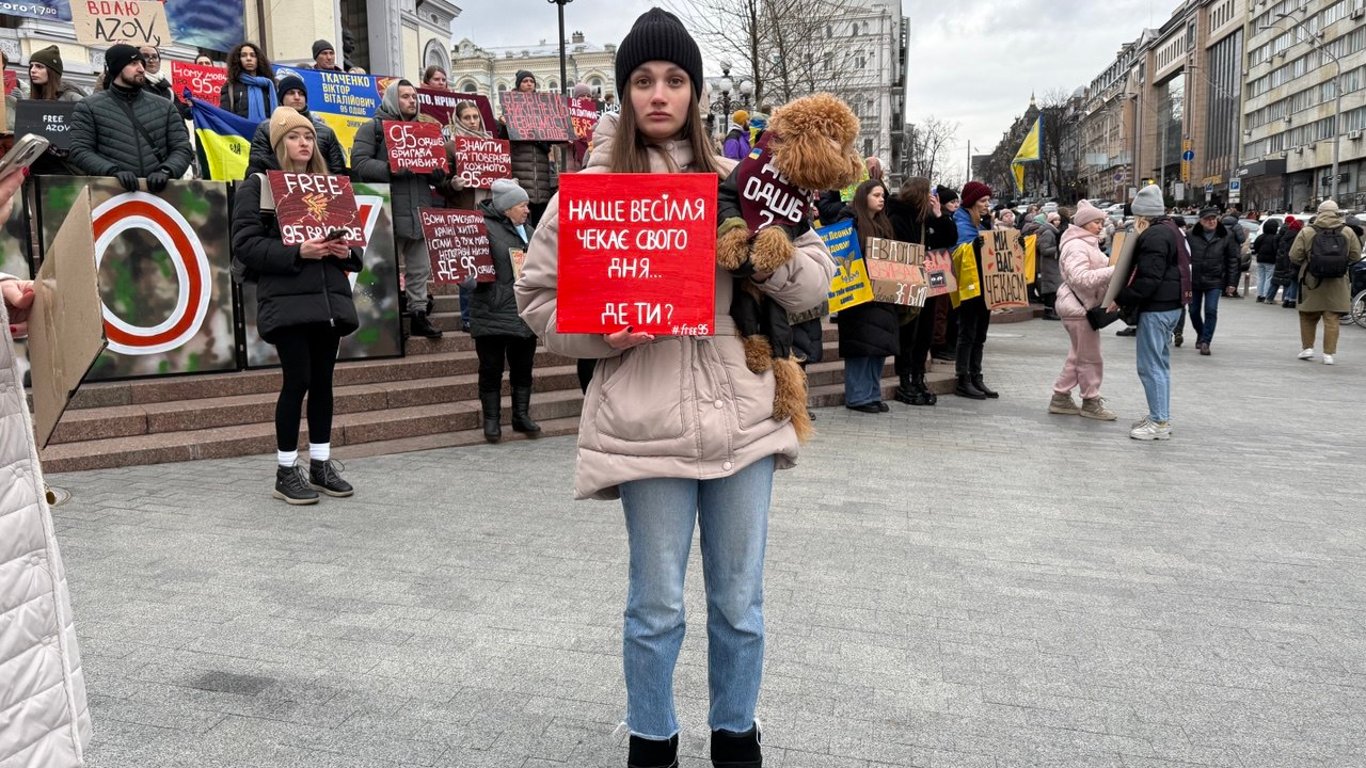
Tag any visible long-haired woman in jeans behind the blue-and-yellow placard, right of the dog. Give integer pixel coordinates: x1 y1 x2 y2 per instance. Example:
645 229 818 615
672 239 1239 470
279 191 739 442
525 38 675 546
835 179 900 413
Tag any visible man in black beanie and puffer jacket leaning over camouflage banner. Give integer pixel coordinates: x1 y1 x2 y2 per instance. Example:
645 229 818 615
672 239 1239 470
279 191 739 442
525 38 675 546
71 44 194 193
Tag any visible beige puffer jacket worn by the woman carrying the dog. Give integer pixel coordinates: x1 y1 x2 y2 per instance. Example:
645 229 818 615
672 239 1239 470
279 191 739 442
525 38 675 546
516 115 835 499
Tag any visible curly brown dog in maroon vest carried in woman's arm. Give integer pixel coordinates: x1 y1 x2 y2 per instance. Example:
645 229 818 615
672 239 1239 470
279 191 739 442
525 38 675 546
716 93 863 441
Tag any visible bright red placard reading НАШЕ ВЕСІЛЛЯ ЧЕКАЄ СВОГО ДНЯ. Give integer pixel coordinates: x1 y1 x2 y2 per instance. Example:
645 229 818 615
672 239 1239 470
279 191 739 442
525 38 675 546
556 174 717 336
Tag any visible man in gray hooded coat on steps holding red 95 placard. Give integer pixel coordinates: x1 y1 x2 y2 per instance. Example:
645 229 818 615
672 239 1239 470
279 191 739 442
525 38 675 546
351 81 445 339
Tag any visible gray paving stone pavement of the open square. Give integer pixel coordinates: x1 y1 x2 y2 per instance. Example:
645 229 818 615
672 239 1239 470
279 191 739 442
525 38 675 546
51 301 1366 768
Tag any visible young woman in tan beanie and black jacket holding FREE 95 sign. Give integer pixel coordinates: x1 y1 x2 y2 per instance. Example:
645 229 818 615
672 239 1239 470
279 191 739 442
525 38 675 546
232 107 361 504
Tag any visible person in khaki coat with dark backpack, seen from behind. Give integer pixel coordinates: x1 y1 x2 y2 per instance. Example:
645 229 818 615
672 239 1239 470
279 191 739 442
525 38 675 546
1290 200 1362 365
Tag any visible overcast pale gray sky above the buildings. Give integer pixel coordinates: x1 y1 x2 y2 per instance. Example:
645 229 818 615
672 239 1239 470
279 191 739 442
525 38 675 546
454 0 1179 176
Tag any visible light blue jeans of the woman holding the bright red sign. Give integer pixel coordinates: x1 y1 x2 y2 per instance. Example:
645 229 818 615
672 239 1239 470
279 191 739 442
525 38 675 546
622 456 775 741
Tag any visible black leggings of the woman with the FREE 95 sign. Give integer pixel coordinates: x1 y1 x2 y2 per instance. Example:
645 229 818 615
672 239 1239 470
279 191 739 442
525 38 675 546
273 323 342 451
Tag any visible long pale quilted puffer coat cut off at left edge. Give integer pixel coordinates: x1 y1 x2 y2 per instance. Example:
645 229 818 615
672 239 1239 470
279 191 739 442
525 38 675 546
0 273 90 768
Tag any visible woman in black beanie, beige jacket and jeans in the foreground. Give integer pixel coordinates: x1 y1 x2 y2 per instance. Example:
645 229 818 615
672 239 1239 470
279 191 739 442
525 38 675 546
516 8 835 768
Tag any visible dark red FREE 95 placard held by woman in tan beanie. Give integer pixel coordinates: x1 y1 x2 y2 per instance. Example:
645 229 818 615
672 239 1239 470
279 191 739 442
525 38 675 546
266 171 366 247
